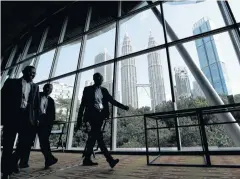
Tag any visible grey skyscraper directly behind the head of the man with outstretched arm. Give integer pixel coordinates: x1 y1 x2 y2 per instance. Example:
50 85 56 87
94 49 113 93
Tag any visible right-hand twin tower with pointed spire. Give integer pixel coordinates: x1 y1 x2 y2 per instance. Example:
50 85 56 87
147 32 166 110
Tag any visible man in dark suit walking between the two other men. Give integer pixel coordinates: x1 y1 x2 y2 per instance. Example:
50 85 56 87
14 84 58 168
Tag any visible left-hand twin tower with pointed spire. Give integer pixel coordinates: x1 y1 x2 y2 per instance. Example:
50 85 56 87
121 33 138 108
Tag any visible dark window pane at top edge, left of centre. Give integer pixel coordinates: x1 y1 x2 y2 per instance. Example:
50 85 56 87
89 1 118 29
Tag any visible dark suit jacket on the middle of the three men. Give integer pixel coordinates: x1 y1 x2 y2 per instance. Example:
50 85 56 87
39 92 56 125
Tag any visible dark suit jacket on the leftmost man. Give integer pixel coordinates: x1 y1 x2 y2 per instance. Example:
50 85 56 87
1 78 40 125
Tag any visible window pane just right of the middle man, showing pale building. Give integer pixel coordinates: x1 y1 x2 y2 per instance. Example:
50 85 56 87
50 75 75 147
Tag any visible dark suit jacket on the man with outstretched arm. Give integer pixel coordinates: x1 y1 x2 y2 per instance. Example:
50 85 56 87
78 86 124 124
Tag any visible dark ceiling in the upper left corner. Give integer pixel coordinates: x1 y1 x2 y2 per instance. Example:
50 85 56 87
1 1 73 53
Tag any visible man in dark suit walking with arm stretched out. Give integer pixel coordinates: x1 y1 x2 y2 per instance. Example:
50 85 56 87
75 73 129 168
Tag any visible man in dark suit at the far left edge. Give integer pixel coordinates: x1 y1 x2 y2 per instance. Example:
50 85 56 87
1 66 40 178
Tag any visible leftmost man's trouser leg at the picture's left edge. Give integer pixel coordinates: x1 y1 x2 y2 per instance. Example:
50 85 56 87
1 125 17 175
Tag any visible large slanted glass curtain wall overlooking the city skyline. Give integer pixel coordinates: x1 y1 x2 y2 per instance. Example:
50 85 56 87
1 0 240 151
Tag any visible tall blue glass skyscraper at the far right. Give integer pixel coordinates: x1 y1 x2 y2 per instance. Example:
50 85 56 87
193 18 231 95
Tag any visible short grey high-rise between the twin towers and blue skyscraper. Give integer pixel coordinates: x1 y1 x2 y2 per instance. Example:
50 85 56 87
174 67 191 99
